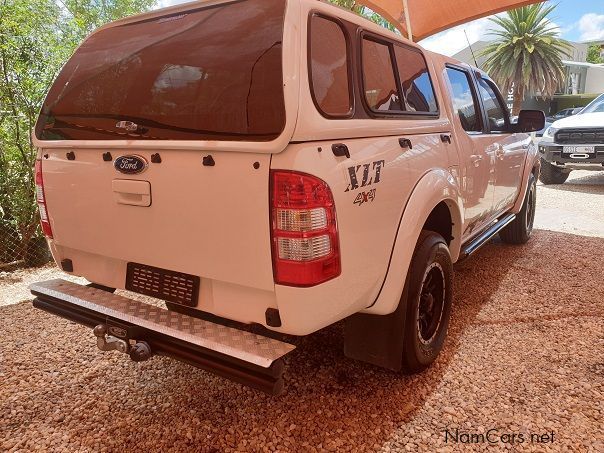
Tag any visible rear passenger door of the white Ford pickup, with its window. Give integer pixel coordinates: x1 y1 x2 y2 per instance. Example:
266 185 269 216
446 65 495 240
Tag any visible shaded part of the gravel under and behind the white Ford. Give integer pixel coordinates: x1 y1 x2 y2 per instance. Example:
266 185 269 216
0 231 604 451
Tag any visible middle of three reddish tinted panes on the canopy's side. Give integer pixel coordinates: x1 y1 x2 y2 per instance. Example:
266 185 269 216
363 39 402 112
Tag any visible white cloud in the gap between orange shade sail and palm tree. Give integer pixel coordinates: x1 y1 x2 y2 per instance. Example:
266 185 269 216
419 18 495 56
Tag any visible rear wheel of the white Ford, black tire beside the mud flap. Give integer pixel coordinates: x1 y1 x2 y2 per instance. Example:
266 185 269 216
401 230 453 374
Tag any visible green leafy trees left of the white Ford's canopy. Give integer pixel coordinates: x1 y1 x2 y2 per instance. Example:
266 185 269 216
0 0 155 261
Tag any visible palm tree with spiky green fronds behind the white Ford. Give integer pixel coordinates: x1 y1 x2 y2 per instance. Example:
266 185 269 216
482 3 572 115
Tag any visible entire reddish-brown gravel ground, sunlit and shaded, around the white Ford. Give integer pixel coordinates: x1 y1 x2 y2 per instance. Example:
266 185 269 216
0 172 604 452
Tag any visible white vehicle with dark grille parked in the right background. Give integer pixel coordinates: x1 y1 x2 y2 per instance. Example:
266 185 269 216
539 94 604 184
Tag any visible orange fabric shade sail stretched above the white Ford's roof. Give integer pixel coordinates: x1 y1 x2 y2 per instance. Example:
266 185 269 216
357 0 543 41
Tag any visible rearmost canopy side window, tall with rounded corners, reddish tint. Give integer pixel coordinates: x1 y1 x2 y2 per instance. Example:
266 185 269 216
310 16 352 116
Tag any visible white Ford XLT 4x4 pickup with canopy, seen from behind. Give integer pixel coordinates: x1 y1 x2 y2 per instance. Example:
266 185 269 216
31 0 544 394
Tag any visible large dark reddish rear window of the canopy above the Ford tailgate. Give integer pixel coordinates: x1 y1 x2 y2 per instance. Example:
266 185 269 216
36 0 286 141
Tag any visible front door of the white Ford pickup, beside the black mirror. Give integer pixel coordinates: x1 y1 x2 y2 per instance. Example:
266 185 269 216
476 75 529 215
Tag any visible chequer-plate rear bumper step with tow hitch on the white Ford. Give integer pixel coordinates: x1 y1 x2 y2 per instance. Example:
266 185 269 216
29 279 295 395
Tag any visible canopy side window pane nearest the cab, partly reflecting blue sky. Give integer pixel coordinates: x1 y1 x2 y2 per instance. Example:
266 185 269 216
394 46 438 112
